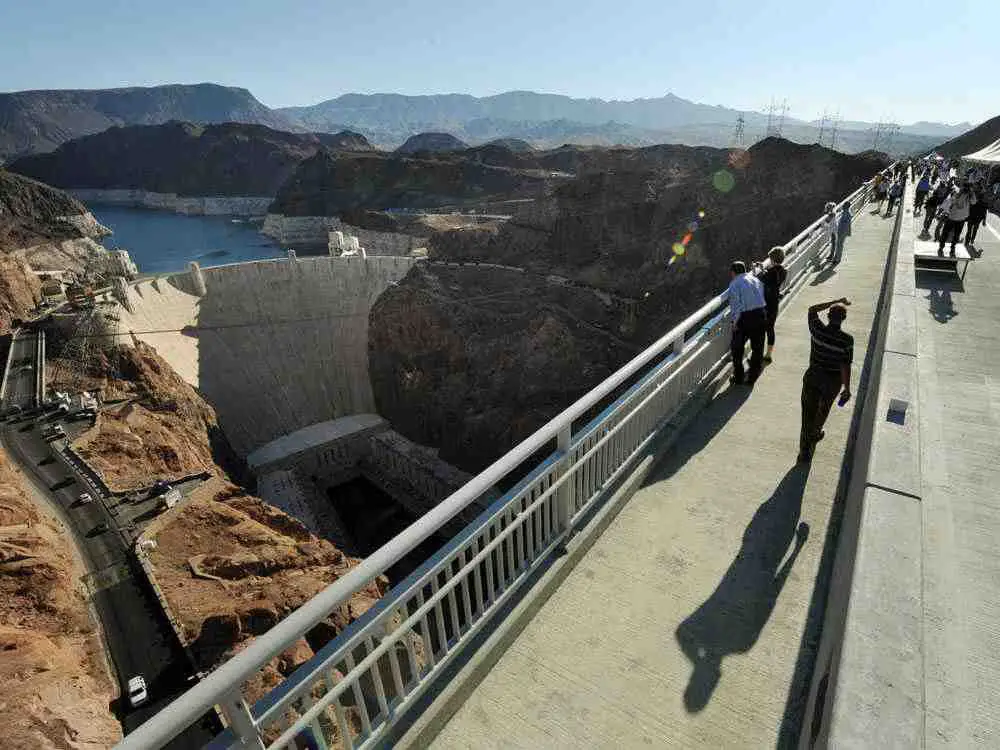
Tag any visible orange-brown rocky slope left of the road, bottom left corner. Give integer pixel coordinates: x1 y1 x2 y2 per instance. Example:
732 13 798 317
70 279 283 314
0 451 121 750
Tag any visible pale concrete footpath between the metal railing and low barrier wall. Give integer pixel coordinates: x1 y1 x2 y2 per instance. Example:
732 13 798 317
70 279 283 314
433 206 900 748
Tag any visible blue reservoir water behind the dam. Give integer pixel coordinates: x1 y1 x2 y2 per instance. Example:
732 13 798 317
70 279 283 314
88 204 285 273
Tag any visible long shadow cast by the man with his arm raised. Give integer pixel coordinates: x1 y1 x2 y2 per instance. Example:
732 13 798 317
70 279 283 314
675 464 809 713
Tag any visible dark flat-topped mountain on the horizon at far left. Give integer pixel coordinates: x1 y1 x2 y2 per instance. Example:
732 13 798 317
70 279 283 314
0 83 295 163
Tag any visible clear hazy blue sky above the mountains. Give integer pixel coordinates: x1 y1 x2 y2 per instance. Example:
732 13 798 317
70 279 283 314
0 0 1000 123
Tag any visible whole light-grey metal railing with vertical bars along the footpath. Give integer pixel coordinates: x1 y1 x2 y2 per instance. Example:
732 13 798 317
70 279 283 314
113 170 888 750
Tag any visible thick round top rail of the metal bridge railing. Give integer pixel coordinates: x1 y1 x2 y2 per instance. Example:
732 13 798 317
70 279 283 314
117 170 888 750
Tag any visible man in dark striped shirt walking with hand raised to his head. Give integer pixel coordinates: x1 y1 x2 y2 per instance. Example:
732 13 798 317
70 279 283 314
798 297 854 462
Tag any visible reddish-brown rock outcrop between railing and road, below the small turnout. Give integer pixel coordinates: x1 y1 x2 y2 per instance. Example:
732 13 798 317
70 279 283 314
147 478 388 702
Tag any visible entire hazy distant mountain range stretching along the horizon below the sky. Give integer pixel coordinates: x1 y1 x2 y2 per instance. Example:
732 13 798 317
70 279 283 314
0 83 984 161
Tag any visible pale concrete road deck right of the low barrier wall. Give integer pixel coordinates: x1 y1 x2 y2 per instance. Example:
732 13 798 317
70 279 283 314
900 204 1000 748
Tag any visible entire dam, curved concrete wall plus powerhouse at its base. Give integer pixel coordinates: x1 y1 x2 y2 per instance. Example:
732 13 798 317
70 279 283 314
105 252 471 554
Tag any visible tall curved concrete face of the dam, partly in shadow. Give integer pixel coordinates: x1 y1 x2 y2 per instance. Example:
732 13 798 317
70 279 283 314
112 256 417 456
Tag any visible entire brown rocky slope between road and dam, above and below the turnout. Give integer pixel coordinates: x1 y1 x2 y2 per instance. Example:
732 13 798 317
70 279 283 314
50 328 387 699
